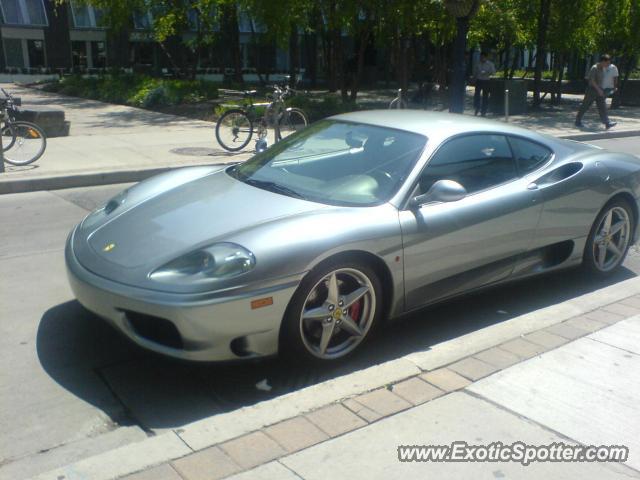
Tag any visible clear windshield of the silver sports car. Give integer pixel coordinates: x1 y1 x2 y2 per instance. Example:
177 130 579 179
227 120 427 206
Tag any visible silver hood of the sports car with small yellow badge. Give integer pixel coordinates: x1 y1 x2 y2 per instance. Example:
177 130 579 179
74 170 327 283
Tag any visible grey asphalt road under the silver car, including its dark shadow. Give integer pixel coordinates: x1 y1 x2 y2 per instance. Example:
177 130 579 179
0 133 640 480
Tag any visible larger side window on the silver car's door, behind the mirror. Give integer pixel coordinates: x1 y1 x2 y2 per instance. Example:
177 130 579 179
420 134 518 193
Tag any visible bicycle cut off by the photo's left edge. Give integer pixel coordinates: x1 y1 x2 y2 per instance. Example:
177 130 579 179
0 89 47 166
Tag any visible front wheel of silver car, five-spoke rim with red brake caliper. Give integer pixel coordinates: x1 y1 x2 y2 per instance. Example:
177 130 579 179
280 262 383 363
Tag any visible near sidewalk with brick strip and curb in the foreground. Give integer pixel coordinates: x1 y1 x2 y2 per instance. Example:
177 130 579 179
31 278 640 480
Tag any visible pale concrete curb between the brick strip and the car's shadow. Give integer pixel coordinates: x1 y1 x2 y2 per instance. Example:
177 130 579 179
34 278 640 480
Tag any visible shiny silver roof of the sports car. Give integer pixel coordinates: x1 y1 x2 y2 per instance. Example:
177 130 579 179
331 109 549 143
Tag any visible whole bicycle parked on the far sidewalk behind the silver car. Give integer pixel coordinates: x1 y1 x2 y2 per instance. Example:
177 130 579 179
216 85 309 152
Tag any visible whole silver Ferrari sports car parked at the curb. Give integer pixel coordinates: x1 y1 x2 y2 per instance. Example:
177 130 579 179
66 110 640 362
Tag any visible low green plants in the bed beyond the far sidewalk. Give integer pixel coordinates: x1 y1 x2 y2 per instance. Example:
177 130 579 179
45 75 218 108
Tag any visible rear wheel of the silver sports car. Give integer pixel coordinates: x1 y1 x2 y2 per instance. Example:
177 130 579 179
583 198 636 276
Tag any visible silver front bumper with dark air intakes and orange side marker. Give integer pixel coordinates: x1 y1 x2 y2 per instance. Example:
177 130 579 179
65 232 303 361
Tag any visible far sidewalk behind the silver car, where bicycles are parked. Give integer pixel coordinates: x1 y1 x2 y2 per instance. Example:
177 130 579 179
0 84 640 194
